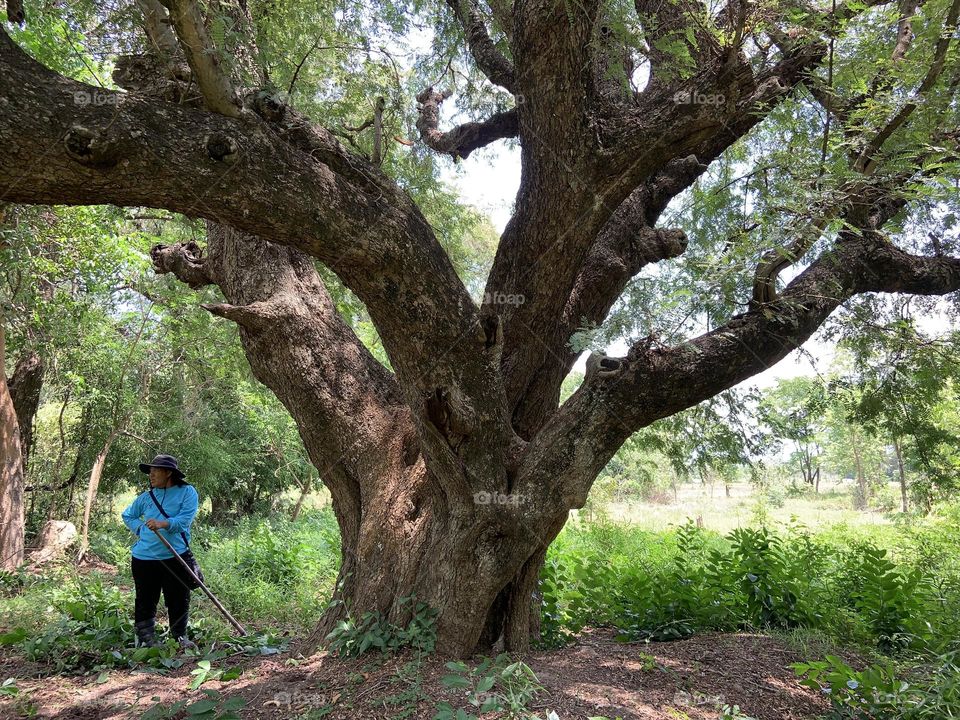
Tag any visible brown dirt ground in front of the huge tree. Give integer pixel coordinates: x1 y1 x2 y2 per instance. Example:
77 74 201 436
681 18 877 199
0 630 826 720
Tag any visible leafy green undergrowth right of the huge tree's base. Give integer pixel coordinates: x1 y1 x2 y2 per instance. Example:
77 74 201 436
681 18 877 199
540 520 960 652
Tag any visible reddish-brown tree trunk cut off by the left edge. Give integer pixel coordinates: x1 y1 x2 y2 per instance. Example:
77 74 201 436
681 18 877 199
0 324 24 570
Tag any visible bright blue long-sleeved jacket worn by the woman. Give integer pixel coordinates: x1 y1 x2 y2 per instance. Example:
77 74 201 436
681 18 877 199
122 485 200 560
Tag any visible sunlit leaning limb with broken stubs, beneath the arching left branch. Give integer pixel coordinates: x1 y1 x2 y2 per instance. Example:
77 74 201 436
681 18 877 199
151 228 415 556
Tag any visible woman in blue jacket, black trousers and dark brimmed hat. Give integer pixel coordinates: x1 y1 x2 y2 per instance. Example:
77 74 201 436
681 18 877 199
122 455 199 648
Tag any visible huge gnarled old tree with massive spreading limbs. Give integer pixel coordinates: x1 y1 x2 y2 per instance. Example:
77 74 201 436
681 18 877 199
0 0 960 653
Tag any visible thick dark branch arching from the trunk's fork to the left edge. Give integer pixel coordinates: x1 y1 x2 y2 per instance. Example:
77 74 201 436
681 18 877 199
0 29 511 498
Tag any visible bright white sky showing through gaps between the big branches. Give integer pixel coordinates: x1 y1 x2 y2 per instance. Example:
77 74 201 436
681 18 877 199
441 135 950 388
